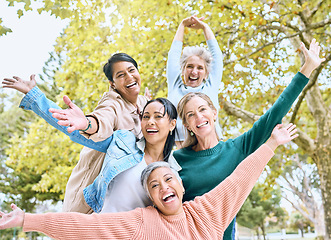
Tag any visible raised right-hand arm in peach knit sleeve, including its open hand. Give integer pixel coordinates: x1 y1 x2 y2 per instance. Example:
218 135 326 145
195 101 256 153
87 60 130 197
194 124 298 236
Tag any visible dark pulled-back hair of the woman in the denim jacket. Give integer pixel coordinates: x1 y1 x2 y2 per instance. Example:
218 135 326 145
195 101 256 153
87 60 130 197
142 98 178 162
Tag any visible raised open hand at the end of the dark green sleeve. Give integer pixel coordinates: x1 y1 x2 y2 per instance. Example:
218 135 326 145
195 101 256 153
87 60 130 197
300 38 325 77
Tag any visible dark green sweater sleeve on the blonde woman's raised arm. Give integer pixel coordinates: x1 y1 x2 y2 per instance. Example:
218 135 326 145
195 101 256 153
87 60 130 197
234 72 309 156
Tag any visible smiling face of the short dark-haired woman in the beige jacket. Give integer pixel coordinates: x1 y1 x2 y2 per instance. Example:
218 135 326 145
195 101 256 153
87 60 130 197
111 61 141 103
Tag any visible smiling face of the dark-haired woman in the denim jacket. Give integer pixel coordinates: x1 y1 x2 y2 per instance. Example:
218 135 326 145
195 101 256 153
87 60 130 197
141 101 176 145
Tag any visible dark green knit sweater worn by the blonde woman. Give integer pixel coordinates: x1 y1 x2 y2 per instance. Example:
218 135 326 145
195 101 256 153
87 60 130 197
174 72 309 240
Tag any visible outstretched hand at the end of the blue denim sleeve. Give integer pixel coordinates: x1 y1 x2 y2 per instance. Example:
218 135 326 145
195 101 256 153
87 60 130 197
2 74 37 94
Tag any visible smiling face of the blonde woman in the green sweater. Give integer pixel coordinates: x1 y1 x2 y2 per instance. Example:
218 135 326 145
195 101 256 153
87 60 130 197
184 97 217 137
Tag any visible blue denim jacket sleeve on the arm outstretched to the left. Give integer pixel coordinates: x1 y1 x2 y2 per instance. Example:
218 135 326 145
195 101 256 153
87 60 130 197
20 87 111 152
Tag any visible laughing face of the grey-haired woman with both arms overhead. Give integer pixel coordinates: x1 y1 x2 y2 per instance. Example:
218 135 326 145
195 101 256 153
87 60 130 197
182 55 207 87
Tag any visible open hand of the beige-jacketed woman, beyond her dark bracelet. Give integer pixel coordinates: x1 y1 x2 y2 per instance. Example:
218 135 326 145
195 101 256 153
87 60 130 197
49 96 88 133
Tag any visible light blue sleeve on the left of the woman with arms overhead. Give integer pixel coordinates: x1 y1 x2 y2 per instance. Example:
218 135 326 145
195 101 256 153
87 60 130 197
167 41 183 92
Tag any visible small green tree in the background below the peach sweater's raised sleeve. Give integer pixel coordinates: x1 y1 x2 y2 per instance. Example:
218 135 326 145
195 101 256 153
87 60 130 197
237 184 285 240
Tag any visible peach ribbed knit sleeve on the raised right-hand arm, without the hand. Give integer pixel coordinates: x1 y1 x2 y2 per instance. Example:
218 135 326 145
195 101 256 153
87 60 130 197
189 144 274 235
